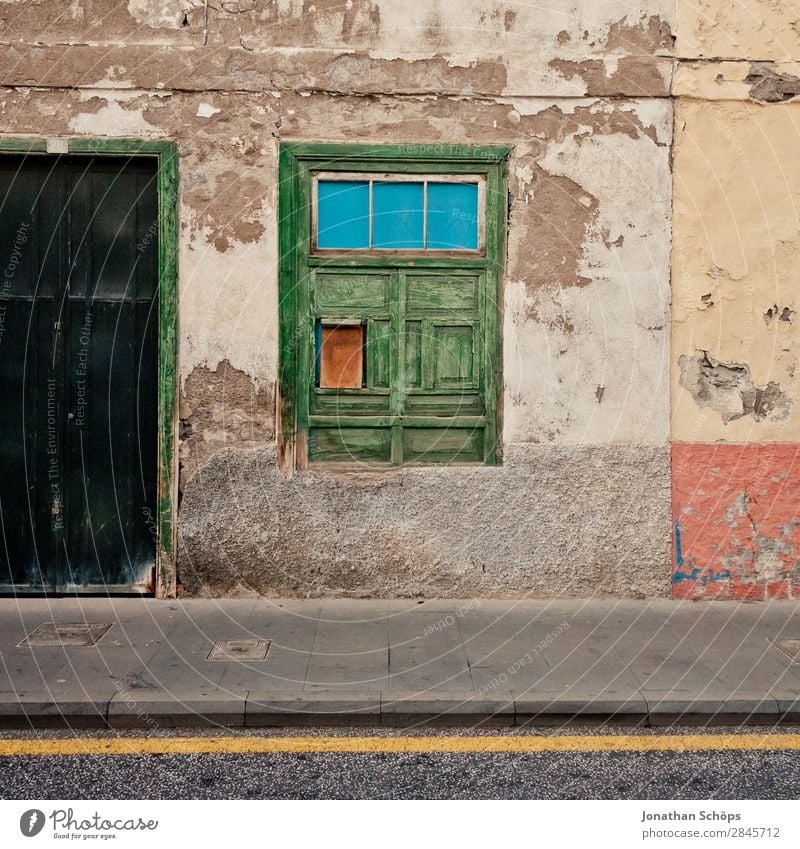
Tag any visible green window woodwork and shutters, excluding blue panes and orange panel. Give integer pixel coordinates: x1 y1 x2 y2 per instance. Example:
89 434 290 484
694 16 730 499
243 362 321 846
277 142 511 474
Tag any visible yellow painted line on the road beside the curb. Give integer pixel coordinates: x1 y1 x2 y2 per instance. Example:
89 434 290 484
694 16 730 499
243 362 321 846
0 734 800 756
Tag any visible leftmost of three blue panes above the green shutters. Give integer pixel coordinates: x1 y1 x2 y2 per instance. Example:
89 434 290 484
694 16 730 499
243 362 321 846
317 180 369 248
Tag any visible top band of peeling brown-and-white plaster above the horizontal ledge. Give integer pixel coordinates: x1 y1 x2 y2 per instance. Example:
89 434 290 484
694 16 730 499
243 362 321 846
0 0 673 96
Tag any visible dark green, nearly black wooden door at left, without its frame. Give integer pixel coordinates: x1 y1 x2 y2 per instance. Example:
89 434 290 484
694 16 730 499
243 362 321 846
0 155 158 592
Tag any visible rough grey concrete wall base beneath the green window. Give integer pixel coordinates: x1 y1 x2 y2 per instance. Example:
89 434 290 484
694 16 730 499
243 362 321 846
178 445 671 598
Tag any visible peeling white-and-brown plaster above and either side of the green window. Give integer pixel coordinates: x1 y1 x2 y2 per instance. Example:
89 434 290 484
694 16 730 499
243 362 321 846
0 90 672 454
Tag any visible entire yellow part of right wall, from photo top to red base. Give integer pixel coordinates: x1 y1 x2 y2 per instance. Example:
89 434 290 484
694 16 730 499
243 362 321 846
672 0 800 442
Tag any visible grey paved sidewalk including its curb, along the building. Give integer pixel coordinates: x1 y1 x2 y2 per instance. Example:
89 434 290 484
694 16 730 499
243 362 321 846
0 598 800 728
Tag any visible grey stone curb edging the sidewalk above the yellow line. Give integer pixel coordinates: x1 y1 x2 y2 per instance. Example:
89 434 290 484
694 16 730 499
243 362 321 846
0 690 800 730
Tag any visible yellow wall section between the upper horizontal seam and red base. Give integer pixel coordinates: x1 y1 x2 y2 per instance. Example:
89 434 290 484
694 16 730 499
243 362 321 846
672 99 800 442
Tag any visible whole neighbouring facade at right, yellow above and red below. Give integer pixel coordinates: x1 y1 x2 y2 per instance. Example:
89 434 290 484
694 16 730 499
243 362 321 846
672 0 800 599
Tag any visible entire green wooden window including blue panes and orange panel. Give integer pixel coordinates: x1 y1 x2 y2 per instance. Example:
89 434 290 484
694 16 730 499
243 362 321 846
279 144 509 467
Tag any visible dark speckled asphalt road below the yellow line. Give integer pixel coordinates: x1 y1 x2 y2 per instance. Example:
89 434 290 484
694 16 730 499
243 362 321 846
0 728 800 799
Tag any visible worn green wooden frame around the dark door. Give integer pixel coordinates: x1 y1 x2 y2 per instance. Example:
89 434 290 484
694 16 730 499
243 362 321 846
0 136 178 598
